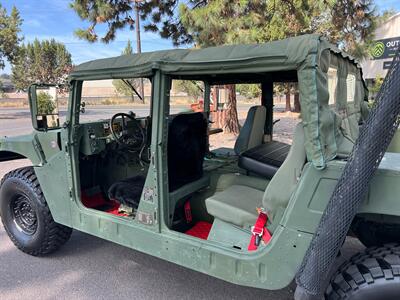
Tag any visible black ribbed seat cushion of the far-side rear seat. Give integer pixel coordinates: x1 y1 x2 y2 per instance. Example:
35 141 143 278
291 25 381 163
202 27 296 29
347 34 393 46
239 141 290 179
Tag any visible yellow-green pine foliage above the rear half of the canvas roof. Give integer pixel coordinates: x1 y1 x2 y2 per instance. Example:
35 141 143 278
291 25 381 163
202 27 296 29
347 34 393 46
176 0 376 113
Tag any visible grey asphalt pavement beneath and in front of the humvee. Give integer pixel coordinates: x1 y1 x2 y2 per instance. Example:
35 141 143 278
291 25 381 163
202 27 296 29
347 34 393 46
0 109 362 300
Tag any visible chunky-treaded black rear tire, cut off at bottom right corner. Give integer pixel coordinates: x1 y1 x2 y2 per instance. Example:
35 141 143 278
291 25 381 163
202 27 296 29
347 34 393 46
325 244 400 300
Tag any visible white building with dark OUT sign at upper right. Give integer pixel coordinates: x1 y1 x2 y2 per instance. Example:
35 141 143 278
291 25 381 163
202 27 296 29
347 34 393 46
362 13 400 80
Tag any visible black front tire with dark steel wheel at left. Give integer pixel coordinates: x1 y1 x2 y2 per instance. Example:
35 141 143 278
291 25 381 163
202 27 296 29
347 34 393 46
0 167 72 256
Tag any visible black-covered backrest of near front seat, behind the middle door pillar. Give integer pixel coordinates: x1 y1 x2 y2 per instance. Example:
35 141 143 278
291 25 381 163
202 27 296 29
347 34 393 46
168 112 208 192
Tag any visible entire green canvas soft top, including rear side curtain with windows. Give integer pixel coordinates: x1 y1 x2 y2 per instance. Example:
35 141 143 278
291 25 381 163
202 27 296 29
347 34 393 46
70 34 367 168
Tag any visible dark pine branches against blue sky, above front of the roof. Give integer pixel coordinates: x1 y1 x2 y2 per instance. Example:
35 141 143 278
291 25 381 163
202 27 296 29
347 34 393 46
70 0 194 45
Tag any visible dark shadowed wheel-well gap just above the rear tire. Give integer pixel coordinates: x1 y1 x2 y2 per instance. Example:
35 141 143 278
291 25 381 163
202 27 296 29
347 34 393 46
351 217 400 247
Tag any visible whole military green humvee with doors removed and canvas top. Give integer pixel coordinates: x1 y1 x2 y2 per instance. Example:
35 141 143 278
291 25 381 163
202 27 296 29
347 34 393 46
0 35 400 299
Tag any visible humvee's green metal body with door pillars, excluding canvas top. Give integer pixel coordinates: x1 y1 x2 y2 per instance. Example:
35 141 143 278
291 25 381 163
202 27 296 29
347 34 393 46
0 34 400 289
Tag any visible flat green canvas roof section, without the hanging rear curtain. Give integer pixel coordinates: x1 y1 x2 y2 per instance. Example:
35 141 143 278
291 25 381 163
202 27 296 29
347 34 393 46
71 35 356 79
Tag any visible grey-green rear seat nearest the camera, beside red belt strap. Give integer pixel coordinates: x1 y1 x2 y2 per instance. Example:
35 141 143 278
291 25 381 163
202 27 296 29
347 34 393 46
206 123 306 227
